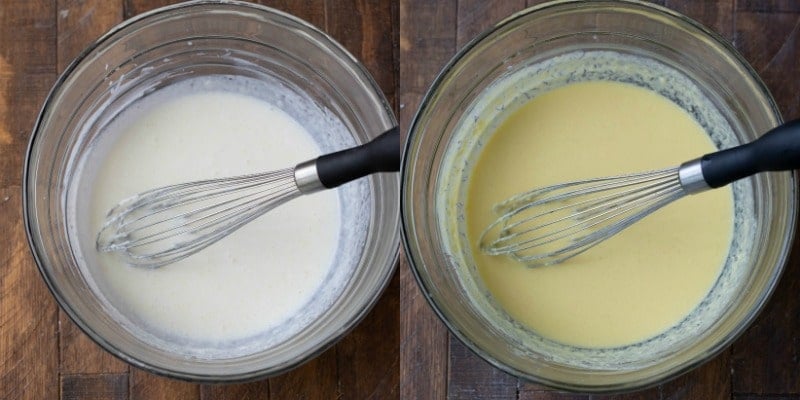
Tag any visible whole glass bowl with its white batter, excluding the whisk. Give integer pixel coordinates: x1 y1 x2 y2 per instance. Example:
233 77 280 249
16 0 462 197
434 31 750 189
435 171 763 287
24 2 399 381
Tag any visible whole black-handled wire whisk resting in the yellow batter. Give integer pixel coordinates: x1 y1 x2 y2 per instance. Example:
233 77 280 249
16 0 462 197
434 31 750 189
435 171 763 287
479 120 800 267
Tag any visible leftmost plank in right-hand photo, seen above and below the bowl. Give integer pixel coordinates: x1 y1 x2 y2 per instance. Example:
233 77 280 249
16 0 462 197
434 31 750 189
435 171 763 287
399 0 457 400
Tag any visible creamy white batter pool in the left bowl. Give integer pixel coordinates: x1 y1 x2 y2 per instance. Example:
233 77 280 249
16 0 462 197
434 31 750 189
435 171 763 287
77 78 348 354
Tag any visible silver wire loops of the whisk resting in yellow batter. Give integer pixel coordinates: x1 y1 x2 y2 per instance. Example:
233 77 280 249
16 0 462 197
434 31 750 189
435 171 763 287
479 168 685 266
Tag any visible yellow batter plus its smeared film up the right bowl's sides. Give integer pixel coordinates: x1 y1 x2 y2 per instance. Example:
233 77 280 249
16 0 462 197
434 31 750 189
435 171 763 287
434 50 757 371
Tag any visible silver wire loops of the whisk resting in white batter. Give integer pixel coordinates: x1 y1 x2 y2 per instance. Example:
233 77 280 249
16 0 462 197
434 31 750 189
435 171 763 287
97 168 301 268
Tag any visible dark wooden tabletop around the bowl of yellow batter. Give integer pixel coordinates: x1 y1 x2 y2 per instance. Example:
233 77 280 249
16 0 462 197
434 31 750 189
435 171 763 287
399 0 800 400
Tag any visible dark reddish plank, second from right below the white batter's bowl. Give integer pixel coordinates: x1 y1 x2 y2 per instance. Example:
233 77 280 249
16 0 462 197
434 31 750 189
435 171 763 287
269 346 341 400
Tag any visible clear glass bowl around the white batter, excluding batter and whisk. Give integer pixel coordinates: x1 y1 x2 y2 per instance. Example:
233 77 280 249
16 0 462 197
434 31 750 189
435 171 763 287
23 2 400 381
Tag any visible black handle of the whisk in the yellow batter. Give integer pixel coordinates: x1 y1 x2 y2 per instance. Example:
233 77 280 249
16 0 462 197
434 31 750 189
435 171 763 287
701 120 800 188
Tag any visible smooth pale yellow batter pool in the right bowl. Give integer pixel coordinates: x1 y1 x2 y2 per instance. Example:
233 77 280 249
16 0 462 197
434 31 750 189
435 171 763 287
466 82 733 347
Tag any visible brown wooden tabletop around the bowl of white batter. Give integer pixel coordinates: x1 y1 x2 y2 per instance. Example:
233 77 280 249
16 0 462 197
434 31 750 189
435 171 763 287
0 0 400 400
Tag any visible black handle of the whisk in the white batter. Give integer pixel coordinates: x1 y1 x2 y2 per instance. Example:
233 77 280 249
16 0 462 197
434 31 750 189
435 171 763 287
317 127 400 189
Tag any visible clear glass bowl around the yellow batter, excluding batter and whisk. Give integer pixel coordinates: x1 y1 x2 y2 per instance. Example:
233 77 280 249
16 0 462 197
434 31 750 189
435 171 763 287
401 1 797 392
